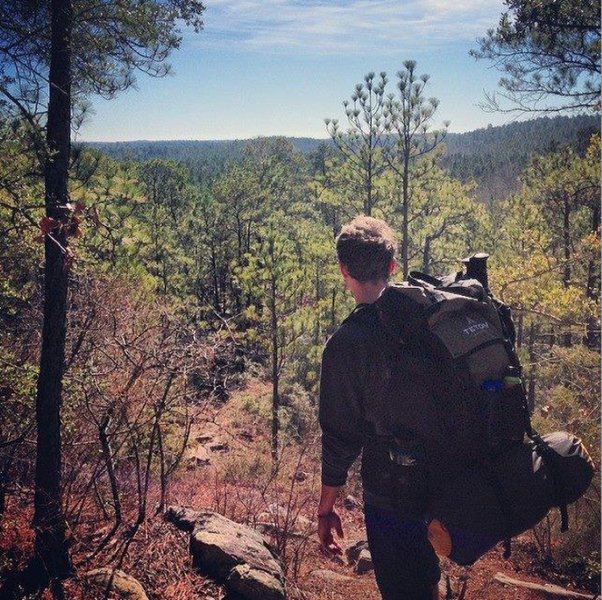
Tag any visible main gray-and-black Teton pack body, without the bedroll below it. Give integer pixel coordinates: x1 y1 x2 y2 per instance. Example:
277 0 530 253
374 272 530 460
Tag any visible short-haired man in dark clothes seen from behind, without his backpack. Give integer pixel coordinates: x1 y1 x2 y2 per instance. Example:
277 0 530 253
318 215 441 600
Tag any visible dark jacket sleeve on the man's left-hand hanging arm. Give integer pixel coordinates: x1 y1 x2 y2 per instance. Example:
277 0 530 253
319 332 365 486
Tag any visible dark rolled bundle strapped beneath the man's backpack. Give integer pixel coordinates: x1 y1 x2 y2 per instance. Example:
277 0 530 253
429 431 595 565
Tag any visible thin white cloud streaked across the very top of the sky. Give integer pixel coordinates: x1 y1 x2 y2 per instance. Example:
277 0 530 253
197 0 503 54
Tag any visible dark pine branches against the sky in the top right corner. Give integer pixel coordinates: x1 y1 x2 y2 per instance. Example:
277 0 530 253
471 0 600 112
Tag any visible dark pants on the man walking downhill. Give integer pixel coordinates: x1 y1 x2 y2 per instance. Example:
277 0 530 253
364 504 441 600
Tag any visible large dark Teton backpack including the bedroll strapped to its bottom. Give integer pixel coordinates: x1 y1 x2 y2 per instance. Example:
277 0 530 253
373 255 593 564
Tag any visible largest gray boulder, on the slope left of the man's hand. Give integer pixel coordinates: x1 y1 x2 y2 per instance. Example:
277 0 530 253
165 506 286 600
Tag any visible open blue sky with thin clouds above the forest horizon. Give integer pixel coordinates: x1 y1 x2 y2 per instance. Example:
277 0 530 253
77 0 512 141
